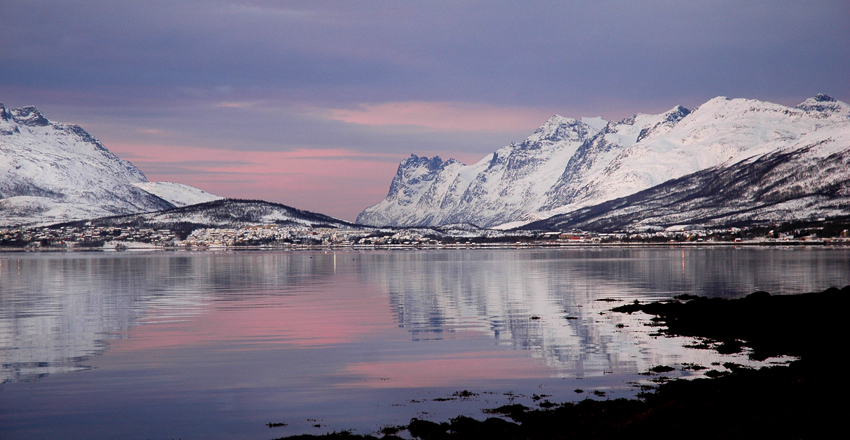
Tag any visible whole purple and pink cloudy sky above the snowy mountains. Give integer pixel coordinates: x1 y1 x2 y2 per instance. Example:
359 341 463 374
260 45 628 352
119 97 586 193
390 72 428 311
0 0 850 218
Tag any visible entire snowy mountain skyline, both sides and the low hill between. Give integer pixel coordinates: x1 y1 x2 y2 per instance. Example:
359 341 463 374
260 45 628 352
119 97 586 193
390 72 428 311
0 94 850 231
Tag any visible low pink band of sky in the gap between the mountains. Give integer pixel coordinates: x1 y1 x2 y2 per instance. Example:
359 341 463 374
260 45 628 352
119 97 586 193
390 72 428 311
111 144 398 220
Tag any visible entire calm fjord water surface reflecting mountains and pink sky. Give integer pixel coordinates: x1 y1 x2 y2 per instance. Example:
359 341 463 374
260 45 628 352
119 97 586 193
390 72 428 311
0 247 850 439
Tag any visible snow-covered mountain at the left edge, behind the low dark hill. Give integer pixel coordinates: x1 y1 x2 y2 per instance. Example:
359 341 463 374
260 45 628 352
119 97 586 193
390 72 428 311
0 104 220 227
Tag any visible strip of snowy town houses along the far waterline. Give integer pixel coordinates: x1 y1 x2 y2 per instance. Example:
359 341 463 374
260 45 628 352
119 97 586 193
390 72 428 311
0 224 850 251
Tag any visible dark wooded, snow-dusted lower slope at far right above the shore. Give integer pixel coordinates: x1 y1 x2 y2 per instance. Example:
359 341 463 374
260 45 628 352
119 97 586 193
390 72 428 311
524 130 850 232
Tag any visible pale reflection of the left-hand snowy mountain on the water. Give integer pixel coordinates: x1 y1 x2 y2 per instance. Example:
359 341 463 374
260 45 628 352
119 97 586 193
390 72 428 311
0 253 342 383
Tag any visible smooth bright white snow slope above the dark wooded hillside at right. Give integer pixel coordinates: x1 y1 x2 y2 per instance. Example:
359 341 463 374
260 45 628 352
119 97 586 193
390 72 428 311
550 97 847 212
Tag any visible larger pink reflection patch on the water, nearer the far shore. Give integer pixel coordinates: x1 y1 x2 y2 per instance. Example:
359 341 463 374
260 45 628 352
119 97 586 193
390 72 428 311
112 283 397 351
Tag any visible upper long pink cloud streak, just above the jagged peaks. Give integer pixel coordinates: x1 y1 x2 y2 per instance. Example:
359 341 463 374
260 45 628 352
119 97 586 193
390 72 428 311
327 101 552 131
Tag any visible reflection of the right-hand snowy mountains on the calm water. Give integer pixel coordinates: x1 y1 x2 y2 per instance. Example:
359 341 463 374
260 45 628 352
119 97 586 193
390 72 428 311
357 248 850 377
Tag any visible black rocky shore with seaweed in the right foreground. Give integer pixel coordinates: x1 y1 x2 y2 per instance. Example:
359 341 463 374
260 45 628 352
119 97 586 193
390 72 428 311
274 286 850 439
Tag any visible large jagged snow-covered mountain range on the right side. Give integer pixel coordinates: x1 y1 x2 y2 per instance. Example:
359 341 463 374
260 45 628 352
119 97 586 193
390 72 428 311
357 94 850 231
